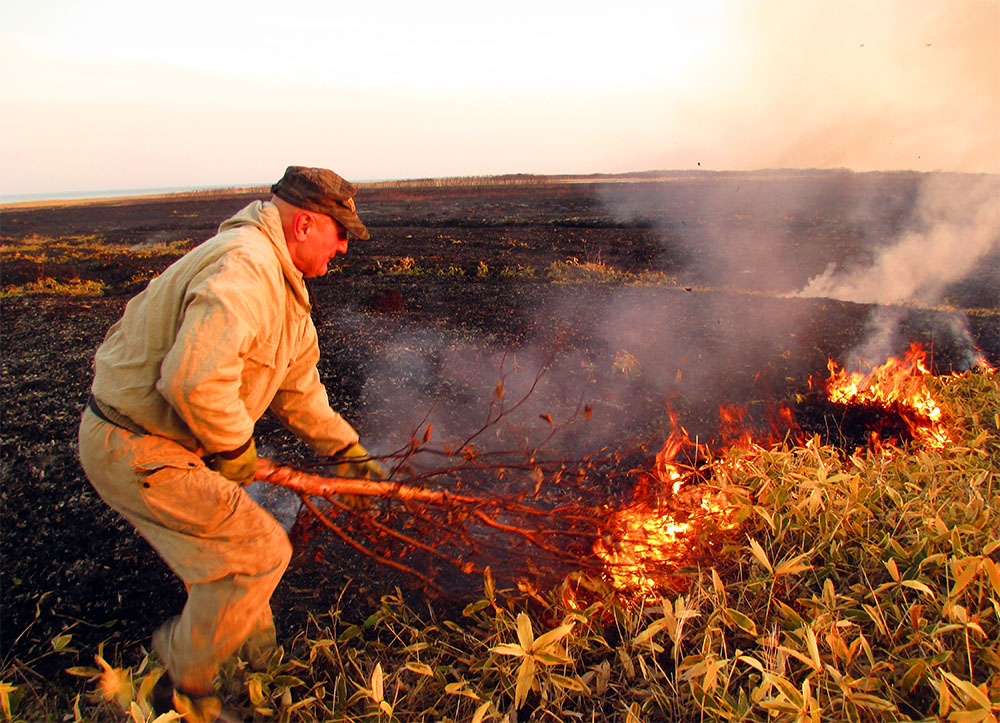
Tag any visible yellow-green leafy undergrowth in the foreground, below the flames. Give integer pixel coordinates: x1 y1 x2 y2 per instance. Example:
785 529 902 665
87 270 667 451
0 371 1000 721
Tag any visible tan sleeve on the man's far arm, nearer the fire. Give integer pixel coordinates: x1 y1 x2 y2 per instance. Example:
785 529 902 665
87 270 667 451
270 315 358 455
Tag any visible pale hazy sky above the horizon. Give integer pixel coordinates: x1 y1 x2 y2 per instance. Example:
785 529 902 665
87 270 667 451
0 0 1000 195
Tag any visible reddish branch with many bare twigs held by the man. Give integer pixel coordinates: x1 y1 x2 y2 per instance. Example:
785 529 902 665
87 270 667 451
257 364 648 595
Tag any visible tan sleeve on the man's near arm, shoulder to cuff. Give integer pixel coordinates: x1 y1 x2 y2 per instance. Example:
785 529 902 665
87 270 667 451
156 253 275 454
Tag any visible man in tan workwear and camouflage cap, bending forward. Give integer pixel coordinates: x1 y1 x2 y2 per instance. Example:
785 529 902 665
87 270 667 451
80 166 384 721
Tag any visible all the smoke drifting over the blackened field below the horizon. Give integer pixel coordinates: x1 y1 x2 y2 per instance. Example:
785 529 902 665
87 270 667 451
350 171 1000 463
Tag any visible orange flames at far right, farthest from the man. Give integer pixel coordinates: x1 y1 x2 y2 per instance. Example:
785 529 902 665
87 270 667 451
826 343 954 449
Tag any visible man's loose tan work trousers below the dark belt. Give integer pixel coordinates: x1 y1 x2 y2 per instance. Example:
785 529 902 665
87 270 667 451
80 409 292 695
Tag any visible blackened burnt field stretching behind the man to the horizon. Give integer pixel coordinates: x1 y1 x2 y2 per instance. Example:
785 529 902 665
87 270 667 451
0 172 1000 675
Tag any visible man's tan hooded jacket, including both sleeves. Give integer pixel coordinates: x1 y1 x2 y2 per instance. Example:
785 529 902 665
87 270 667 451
93 201 358 455
